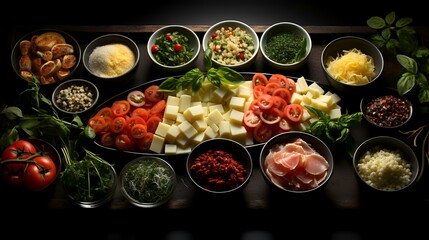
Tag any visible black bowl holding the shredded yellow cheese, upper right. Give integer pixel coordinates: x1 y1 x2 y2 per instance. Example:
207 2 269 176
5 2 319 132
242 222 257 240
321 36 384 96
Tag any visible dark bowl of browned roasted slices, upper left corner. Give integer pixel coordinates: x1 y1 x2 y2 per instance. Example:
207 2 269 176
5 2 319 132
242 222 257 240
11 29 81 85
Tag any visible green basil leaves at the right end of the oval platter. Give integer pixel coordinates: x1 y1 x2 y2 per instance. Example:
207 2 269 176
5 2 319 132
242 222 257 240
305 105 363 157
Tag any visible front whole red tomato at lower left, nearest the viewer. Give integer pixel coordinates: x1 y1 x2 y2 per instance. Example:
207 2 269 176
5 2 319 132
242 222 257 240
22 155 57 191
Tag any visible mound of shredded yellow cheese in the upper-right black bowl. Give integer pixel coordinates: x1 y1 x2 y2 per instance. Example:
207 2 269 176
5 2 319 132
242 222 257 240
327 48 375 85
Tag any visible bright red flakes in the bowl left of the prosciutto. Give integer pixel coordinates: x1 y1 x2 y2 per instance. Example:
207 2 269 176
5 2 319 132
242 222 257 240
190 150 247 191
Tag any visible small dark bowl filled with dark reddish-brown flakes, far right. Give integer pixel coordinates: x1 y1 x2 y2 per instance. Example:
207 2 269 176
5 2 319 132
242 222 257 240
360 88 413 130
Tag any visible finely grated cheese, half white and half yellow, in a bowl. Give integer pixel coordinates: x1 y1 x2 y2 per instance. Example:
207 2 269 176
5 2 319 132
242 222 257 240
88 43 135 78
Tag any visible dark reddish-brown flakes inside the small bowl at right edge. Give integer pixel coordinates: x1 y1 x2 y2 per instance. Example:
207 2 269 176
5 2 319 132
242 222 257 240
364 95 410 127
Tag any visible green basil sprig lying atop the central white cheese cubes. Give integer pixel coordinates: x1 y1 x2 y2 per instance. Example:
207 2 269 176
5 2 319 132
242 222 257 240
158 48 245 94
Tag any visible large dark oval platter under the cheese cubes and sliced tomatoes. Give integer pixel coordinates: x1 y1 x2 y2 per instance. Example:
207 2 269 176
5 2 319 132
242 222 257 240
89 72 347 159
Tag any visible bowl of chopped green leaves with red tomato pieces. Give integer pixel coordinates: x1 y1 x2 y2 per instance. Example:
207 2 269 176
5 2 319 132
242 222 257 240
147 25 201 73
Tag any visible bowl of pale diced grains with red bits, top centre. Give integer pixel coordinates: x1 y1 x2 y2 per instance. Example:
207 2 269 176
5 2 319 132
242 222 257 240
201 20 259 69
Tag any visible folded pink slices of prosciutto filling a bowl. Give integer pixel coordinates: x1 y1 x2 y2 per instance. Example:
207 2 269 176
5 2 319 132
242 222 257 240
265 138 330 191
